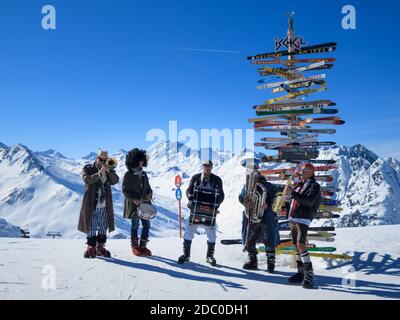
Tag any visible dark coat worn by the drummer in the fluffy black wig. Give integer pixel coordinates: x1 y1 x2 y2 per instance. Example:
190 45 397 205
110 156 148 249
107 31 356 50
122 169 153 219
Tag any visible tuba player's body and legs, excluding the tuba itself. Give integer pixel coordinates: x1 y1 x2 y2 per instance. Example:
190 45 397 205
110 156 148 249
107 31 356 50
239 168 279 273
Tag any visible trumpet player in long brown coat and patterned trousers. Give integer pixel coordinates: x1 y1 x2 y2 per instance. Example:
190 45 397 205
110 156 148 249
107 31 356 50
78 150 119 258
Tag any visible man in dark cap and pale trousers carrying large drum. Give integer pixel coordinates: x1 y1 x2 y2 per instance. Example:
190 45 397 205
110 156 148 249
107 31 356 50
178 160 225 266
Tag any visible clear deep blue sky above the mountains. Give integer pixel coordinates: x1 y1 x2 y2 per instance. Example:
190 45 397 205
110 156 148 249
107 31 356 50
0 0 400 157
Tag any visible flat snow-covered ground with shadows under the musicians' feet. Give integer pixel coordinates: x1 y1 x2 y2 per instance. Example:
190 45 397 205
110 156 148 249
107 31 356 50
0 225 400 300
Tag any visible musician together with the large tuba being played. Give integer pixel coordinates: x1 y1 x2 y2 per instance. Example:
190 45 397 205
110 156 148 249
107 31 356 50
239 160 279 273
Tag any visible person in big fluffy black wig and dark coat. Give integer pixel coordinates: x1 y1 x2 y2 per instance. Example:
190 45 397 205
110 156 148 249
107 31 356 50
122 148 153 256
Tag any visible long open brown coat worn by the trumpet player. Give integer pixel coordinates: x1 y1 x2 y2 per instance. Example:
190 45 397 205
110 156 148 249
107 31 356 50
78 164 119 233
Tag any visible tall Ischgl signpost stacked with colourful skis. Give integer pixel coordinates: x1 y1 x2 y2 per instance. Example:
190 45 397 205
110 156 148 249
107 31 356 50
247 15 345 260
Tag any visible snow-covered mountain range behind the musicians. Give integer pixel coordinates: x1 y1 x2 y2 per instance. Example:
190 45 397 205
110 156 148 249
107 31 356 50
0 142 400 238
